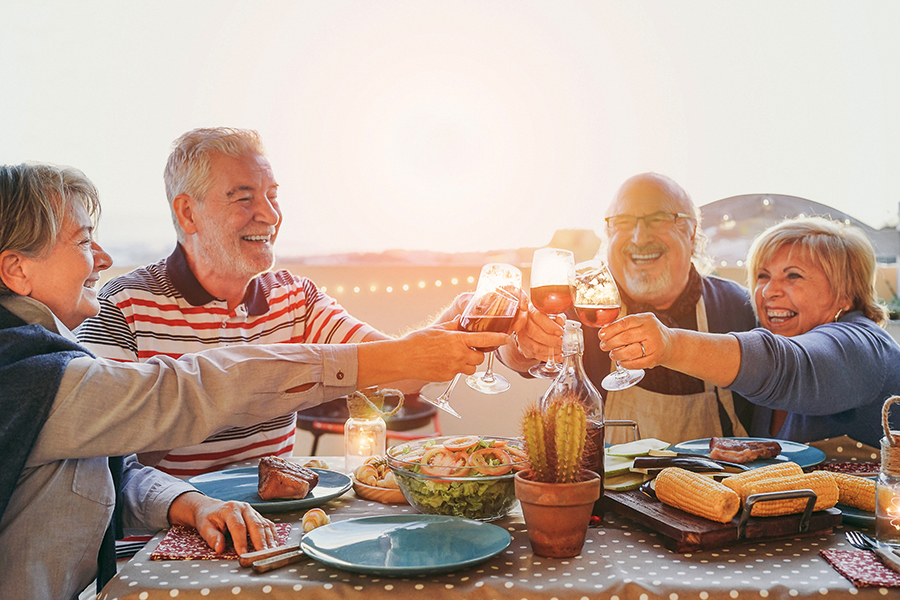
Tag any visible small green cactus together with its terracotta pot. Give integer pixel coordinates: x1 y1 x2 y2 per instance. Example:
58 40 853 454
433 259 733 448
515 395 601 558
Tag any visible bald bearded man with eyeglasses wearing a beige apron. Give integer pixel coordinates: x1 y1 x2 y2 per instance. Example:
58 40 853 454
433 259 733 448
584 173 756 443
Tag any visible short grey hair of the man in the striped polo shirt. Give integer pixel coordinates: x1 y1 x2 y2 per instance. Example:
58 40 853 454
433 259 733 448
163 127 266 242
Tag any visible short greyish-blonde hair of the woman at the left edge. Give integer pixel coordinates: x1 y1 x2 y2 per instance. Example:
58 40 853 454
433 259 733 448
0 163 100 292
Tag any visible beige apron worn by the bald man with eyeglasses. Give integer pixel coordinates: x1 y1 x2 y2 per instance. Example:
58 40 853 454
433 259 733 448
603 296 747 444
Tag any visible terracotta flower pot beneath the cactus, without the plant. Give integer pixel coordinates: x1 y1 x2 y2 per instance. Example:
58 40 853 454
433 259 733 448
516 470 602 558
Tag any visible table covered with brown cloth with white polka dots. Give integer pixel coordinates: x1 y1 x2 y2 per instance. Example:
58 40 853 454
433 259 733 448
99 436 898 600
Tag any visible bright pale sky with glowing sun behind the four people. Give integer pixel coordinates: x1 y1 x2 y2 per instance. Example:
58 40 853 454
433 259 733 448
0 0 900 257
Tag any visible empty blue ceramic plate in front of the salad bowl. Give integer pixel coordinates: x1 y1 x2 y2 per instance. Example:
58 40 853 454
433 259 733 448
300 515 512 577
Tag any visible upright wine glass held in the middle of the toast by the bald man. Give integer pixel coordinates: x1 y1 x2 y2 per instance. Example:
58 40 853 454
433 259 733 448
528 248 575 379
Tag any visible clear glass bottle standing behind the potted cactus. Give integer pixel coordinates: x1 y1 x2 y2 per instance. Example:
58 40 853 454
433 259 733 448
541 320 605 518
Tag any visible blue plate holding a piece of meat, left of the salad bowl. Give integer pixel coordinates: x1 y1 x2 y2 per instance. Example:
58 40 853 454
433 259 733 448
188 467 352 514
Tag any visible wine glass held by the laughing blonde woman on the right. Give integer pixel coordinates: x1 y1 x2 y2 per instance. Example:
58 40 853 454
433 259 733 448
574 260 644 391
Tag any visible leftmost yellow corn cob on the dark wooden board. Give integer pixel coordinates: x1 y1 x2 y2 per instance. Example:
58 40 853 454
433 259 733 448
654 467 741 523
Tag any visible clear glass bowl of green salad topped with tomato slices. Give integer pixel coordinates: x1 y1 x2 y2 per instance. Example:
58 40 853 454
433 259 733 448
387 435 529 521
